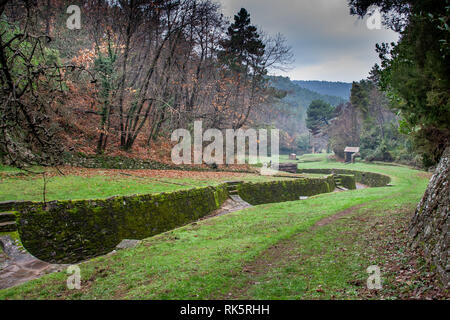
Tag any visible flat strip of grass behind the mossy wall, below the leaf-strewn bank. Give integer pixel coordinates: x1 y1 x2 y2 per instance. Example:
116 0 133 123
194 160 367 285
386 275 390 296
0 167 290 201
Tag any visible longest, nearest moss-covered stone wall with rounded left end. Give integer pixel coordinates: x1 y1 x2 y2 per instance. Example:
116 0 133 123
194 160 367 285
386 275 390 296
16 185 228 263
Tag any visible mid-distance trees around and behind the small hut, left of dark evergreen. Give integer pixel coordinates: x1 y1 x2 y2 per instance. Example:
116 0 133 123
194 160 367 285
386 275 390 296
306 73 421 166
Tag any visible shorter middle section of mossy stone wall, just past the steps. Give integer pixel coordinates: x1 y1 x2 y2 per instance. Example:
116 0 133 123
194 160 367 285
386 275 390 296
237 176 335 205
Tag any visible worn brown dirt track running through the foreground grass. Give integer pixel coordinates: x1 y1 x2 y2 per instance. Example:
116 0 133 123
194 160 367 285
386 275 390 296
219 203 366 300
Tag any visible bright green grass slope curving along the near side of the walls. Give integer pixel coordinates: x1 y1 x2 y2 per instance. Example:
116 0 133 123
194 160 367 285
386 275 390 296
0 161 428 299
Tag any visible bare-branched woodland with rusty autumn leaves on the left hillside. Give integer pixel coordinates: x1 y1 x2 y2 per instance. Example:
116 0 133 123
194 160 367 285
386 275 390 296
0 0 291 166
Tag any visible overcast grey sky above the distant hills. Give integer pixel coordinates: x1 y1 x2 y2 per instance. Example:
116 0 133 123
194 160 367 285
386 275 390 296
218 0 398 82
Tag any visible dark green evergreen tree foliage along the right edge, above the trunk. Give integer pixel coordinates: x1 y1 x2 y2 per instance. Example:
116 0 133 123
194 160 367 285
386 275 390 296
349 0 450 166
